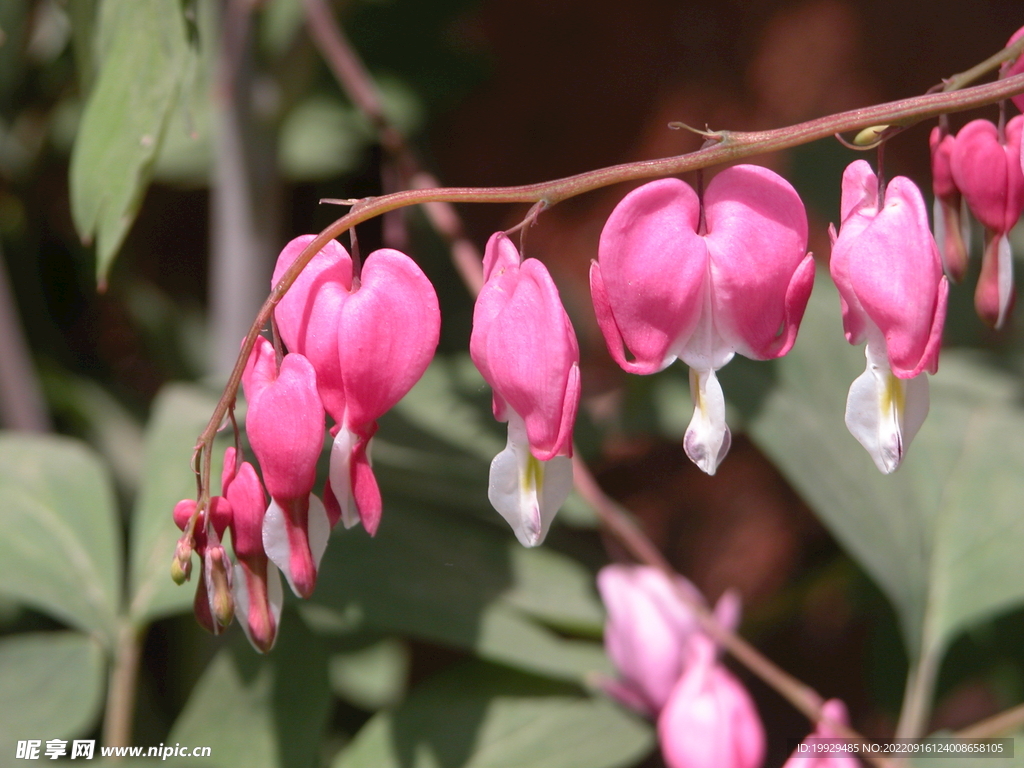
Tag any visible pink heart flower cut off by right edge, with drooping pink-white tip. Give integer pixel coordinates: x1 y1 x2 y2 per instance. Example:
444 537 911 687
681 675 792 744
950 115 1024 328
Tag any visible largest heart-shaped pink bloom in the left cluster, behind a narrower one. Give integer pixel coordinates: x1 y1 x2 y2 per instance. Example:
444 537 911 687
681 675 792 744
273 234 440 536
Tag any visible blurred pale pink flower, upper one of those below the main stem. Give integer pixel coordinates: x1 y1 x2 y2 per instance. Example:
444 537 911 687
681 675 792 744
597 565 739 718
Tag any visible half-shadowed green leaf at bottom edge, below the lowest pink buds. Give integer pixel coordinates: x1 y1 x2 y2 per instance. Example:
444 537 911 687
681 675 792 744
167 612 330 768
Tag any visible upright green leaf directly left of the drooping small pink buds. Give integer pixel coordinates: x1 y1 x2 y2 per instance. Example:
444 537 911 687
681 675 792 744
129 384 220 626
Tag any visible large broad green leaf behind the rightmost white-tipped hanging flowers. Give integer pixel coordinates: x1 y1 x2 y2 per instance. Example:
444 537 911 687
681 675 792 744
751 281 1024 657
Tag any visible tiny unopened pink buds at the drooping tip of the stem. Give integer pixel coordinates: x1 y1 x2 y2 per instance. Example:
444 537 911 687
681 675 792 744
173 496 234 635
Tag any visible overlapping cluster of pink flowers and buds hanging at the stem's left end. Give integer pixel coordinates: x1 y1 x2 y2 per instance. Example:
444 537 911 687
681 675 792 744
175 236 440 651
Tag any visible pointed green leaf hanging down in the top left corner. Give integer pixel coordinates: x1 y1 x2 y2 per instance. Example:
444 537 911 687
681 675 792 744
71 0 191 285
